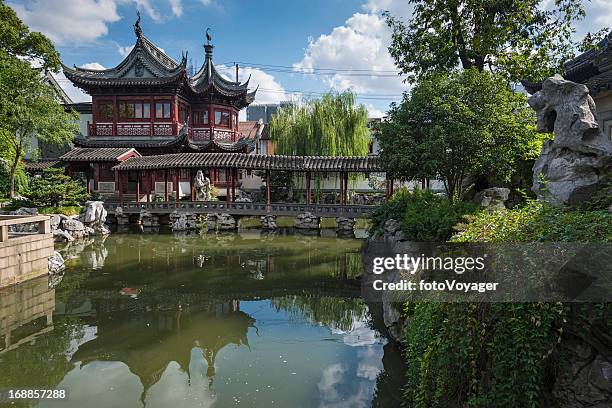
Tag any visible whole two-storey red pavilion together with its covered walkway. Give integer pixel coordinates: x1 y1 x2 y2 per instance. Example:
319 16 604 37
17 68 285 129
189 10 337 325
52 15 380 204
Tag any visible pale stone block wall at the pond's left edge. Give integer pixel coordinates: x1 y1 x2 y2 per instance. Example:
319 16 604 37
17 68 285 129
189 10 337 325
0 234 54 287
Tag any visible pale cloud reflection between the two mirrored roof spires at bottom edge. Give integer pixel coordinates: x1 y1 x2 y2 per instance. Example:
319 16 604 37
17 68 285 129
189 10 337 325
145 347 216 408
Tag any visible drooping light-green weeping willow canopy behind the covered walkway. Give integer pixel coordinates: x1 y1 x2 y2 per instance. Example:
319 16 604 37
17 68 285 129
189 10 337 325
270 92 370 156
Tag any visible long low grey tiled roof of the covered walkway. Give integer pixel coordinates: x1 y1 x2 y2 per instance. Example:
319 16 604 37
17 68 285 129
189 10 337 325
113 153 383 172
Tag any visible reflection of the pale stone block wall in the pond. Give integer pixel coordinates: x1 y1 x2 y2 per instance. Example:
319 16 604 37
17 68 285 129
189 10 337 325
0 275 55 354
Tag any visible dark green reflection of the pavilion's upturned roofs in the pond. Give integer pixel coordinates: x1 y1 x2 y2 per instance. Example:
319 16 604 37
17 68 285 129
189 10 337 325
72 300 255 401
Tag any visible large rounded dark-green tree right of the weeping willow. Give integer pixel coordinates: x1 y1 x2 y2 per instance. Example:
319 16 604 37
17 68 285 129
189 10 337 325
377 69 542 200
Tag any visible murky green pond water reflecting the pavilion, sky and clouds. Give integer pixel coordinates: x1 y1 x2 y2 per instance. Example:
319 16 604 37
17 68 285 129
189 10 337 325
0 231 404 408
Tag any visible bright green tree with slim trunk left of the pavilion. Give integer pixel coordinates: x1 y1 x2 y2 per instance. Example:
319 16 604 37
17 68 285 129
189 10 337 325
0 51 78 197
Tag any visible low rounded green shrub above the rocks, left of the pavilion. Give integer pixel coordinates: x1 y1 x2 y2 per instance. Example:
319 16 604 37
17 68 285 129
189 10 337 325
26 168 89 207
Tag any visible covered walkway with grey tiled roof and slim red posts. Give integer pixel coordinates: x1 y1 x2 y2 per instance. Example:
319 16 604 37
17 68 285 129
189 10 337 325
112 153 393 207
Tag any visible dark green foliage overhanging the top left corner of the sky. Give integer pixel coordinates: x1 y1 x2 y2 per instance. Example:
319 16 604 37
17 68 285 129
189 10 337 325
0 0 61 71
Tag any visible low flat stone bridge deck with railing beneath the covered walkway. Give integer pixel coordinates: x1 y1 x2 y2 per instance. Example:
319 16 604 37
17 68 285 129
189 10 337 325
104 201 376 218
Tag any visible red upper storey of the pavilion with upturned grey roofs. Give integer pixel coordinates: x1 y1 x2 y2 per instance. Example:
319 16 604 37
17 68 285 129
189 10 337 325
63 16 257 156
